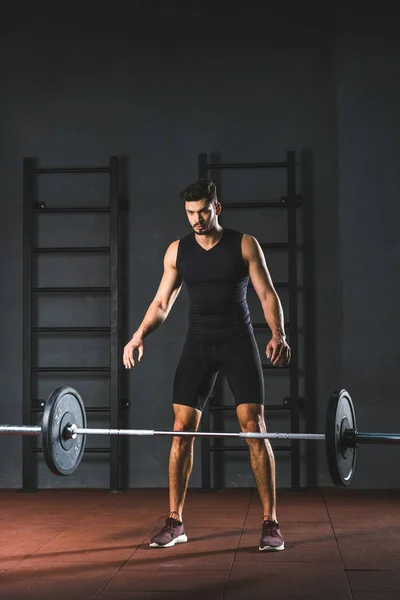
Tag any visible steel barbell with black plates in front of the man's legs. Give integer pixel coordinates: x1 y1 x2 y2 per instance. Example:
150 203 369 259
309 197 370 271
0 386 400 487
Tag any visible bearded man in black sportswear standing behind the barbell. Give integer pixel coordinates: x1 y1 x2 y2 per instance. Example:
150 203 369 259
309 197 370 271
123 180 290 550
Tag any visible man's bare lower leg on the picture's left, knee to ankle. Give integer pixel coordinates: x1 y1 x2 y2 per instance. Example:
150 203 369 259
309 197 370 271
169 404 201 521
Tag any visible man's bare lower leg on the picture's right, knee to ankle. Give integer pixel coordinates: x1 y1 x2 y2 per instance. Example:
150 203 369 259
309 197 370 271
237 404 277 521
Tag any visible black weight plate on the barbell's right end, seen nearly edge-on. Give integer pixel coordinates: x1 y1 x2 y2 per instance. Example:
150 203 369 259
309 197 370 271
325 390 357 487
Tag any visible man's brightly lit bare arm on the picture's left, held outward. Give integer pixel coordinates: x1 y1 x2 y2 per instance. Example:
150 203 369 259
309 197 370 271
123 240 182 369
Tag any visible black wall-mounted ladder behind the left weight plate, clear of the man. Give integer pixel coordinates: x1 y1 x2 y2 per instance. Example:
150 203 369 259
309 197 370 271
22 156 122 491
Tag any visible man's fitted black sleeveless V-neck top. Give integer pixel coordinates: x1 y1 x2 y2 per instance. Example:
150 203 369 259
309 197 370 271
176 229 252 342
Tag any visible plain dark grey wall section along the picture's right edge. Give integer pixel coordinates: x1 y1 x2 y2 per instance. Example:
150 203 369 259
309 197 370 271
335 15 400 488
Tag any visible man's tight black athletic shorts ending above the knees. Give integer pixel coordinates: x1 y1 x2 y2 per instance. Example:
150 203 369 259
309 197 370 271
173 332 265 411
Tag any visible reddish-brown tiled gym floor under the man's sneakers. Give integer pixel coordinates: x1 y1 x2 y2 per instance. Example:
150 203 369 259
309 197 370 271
0 488 400 600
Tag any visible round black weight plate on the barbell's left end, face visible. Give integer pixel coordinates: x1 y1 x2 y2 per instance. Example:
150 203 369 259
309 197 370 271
42 386 86 475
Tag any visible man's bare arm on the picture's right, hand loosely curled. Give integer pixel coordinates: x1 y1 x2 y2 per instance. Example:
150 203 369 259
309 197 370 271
242 234 290 367
